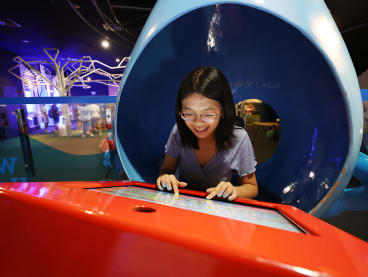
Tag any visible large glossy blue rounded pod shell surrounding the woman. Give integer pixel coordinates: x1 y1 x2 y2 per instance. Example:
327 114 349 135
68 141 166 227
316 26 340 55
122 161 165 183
116 0 362 215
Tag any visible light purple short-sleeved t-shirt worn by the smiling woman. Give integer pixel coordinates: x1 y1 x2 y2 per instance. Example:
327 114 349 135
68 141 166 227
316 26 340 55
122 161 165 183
165 124 257 190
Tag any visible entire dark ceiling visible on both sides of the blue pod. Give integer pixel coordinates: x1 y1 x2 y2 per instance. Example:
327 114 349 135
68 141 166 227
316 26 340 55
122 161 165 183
0 0 368 75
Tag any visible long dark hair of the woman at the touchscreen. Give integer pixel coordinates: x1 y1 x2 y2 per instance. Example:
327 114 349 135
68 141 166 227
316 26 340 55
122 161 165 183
175 67 235 151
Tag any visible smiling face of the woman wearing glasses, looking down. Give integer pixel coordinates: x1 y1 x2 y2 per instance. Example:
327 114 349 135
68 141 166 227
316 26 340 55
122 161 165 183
181 93 222 139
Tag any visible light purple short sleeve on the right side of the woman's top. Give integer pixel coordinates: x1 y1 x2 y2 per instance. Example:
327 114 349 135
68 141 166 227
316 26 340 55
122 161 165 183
235 130 257 177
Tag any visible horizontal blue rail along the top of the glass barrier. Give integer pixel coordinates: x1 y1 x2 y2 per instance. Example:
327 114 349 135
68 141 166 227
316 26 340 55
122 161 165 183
0 96 117 105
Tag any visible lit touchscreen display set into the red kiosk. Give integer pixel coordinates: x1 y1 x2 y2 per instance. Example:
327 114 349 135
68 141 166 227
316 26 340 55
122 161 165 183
90 186 302 233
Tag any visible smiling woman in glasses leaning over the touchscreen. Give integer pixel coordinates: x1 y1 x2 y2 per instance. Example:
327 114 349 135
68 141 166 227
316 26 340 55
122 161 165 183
157 67 258 201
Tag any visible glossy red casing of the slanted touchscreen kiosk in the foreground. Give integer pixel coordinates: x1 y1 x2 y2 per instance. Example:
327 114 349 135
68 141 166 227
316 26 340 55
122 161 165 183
0 182 368 277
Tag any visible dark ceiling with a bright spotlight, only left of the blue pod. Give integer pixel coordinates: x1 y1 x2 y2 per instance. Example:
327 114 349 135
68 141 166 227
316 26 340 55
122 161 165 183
0 0 156 64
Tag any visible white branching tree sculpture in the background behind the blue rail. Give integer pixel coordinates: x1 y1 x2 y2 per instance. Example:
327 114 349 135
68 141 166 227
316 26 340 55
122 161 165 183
8 48 129 137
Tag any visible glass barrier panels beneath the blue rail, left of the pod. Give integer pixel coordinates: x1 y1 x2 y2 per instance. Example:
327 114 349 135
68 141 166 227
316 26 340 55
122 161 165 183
0 103 125 182
